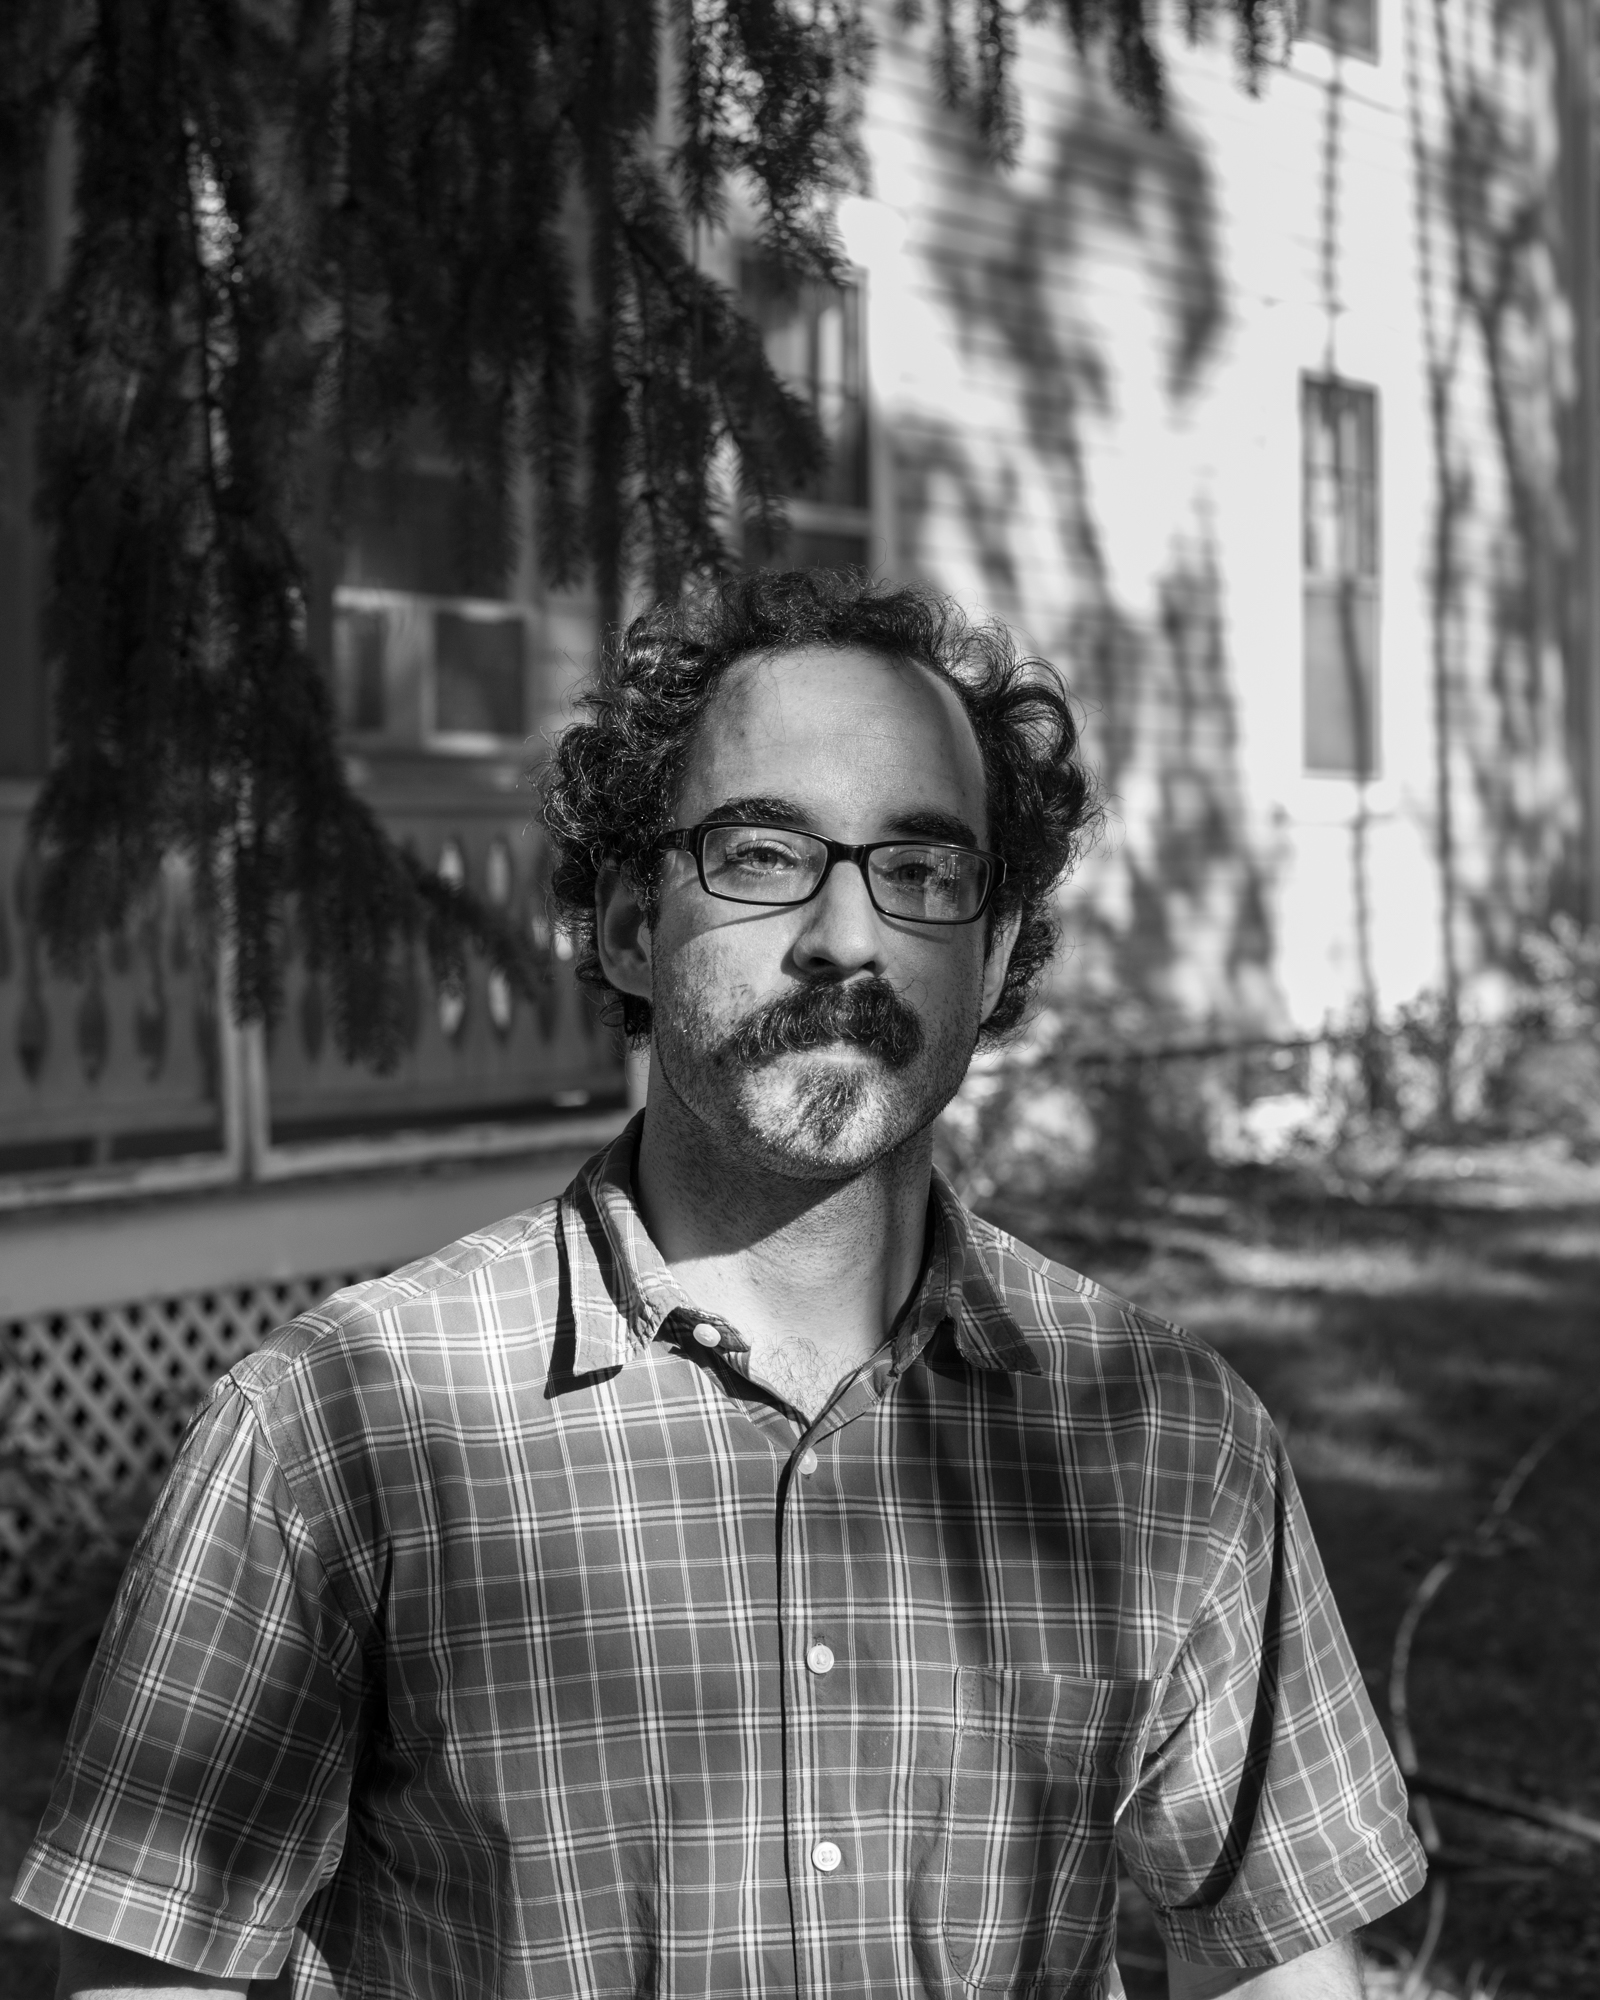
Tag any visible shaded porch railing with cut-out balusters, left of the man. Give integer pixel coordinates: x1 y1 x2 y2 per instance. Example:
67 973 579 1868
0 786 624 1208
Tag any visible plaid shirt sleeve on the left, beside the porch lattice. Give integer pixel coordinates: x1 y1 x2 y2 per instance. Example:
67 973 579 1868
14 1382 360 1978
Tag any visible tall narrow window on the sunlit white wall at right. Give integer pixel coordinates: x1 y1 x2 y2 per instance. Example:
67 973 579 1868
1300 376 1380 778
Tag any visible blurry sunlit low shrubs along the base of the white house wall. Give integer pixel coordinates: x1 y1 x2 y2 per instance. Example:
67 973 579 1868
938 916 1600 1206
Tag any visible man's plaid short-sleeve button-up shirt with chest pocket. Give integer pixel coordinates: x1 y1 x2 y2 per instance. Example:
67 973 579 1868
16 1128 1424 2000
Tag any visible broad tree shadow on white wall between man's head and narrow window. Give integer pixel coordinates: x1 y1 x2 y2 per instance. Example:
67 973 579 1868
898 78 1280 1030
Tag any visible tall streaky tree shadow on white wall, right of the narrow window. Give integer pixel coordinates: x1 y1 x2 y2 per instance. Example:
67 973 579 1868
1406 0 1594 996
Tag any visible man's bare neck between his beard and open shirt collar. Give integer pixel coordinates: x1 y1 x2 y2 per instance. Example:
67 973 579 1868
636 1080 932 1384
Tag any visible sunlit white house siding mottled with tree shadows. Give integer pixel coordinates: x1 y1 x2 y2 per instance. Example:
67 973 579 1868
868 0 1582 1032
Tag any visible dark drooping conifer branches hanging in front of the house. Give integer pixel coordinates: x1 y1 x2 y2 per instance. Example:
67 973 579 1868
0 0 1276 1064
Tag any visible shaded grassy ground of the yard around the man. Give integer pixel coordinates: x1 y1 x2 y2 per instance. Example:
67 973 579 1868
0 1148 1600 2000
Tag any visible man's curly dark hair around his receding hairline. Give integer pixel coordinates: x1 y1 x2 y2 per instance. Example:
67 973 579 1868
540 570 1100 1042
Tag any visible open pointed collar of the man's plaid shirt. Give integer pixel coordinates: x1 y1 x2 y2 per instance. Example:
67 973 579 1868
560 1112 1042 1374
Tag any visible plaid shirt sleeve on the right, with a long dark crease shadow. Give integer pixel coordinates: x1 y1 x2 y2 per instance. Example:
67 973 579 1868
1118 1426 1426 1966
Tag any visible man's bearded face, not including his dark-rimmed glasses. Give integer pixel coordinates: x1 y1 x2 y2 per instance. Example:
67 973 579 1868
620 648 1012 1180
